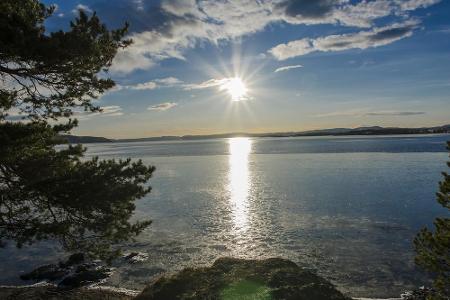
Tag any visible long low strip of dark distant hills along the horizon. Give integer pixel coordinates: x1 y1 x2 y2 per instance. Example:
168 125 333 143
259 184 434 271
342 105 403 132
62 124 450 144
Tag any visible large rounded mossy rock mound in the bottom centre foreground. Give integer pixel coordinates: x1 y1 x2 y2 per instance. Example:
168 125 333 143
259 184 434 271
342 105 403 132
136 258 350 300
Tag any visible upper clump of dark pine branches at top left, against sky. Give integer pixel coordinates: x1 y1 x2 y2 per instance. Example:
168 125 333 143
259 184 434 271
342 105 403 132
0 0 131 119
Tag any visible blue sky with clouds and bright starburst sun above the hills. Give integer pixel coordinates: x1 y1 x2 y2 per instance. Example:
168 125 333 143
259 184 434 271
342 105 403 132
45 0 450 138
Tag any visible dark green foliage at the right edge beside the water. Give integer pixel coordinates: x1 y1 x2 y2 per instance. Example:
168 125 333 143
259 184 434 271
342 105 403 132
414 142 450 299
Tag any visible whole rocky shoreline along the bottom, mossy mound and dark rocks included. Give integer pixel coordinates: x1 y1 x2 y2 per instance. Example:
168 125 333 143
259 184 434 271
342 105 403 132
0 253 432 300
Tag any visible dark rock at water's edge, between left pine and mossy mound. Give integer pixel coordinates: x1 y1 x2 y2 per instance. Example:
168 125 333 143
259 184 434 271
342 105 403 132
58 265 111 288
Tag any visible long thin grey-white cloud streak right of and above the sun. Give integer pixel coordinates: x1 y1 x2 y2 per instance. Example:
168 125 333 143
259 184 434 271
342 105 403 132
268 20 419 60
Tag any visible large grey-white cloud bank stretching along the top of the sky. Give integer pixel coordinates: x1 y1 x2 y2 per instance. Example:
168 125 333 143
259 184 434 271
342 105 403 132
103 0 439 74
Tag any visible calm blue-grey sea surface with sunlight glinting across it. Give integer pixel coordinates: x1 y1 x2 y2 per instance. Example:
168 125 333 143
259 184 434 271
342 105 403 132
0 135 450 297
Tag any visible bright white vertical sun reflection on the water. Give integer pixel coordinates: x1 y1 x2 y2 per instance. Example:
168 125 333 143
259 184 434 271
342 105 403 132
228 137 252 231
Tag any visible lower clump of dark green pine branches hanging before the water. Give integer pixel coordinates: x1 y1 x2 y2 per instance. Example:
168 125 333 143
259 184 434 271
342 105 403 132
0 123 154 255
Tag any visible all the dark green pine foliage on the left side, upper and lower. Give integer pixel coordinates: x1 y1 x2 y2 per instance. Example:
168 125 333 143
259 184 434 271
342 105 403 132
0 0 154 258
